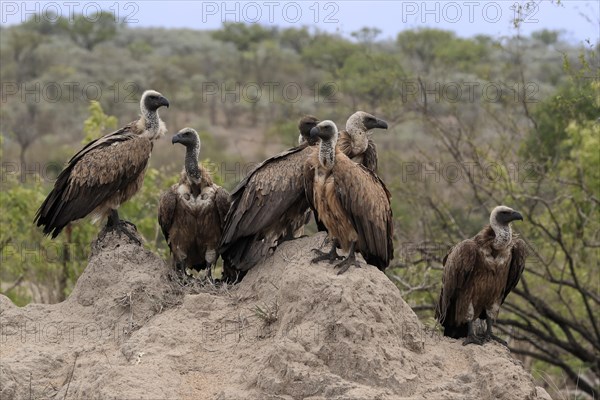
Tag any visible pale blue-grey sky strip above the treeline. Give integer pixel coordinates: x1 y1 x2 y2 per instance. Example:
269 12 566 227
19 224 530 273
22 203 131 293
0 0 600 43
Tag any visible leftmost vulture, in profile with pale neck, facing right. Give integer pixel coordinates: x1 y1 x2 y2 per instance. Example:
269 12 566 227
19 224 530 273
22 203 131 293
34 90 169 244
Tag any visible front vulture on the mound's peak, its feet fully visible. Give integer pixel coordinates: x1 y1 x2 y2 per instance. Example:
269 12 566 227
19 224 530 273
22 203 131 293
304 121 394 274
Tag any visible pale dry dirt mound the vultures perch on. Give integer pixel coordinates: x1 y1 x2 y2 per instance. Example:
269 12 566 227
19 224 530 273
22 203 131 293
0 228 550 400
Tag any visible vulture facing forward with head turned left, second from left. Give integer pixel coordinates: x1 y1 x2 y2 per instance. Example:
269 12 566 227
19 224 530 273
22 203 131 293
158 128 229 277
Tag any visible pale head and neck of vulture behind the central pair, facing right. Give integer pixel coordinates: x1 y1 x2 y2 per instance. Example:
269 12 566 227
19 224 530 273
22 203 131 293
337 111 388 173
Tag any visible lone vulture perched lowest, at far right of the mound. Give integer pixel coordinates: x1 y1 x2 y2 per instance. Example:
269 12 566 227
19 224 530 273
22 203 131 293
436 206 527 345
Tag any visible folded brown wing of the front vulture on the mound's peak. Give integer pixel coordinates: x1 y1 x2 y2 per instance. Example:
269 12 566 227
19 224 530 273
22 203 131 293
333 152 394 270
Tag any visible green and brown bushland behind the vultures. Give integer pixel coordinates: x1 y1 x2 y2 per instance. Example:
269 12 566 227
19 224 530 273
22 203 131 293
0 8 600 398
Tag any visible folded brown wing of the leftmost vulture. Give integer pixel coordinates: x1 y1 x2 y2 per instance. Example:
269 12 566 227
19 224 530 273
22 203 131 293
34 124 152 238
